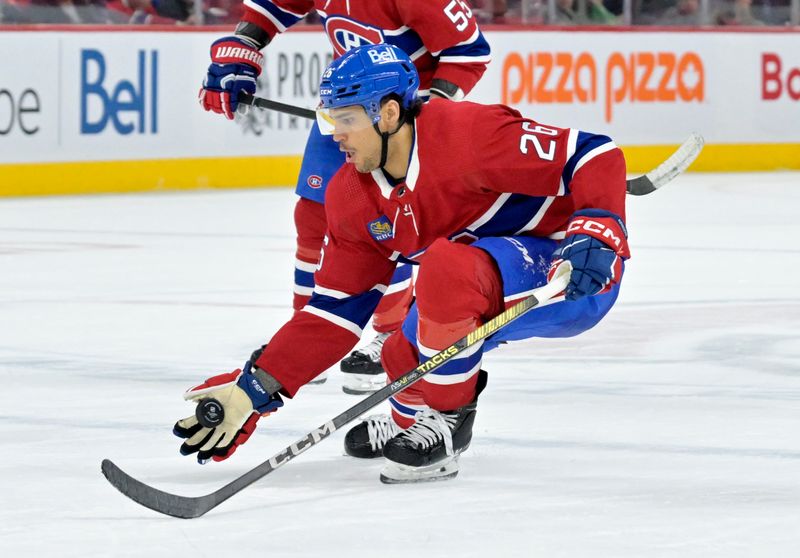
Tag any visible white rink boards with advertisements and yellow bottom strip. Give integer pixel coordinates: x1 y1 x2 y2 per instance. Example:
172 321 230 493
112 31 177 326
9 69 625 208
0 27 800 195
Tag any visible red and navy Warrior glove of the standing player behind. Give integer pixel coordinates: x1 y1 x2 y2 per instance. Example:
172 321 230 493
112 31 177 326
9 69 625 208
199 35 264 120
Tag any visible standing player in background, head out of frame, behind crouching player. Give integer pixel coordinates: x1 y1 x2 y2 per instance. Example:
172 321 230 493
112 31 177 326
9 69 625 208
200 0 490 394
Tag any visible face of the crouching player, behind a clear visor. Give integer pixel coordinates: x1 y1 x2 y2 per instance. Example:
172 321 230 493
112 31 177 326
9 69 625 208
329 106 381 173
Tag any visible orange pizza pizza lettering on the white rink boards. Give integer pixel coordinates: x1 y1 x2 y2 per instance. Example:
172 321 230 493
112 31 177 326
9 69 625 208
502 51 705 122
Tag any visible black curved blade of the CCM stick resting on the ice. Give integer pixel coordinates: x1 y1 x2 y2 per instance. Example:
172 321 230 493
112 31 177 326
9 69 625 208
100 459 216 519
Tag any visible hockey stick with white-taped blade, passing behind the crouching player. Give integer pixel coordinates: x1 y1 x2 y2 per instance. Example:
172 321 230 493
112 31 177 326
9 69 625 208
238 91 705 196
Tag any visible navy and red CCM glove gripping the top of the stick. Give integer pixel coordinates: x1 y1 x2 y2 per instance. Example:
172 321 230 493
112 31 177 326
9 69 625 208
550 209 630 300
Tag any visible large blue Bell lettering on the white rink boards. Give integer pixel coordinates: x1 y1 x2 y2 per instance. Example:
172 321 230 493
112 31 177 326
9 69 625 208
81 49 158 135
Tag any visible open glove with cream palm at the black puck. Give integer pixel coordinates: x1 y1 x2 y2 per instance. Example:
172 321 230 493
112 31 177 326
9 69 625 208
173 361 283 463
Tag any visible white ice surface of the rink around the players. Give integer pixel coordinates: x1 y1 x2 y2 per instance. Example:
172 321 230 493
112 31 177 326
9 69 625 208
0 173 800 558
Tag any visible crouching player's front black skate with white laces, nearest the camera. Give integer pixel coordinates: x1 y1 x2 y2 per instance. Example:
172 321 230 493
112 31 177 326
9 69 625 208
381 370 486 484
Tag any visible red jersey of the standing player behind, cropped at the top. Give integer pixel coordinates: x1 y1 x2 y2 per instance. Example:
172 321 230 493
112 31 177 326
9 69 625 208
242 0 490 99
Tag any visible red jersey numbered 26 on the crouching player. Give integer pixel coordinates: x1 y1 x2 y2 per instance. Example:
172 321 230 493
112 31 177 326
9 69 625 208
257 100 626 395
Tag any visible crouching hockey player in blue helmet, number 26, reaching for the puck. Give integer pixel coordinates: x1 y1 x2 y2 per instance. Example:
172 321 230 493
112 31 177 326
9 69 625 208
175 45 629 483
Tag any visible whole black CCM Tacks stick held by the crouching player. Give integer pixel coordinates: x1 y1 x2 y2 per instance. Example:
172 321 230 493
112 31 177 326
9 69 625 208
102 263 572 519
